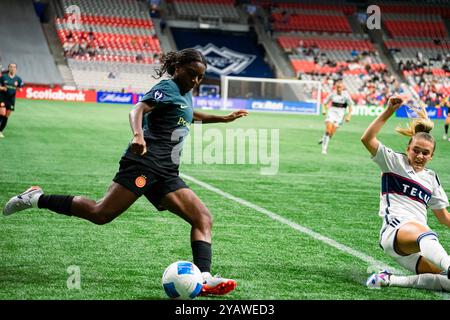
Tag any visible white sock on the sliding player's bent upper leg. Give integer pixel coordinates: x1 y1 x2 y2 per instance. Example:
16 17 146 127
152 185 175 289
417 231 450 271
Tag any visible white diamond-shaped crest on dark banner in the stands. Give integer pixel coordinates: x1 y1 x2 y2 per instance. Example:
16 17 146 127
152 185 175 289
195 43 256 76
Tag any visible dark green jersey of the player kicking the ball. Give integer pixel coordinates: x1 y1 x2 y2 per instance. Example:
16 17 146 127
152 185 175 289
125 79 194 176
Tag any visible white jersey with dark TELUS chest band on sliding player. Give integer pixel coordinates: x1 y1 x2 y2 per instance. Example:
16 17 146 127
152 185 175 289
372 143 449 225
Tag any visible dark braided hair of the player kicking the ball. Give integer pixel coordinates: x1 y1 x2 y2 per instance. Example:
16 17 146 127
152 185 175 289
154 48 207 79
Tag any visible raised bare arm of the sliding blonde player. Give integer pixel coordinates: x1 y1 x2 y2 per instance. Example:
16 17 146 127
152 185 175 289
361 96 403 156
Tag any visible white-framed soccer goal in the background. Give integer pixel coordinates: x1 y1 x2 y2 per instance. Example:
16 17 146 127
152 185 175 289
221 76 322 114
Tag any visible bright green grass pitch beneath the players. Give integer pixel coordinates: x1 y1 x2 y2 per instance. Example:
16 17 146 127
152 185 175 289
0 100 450 300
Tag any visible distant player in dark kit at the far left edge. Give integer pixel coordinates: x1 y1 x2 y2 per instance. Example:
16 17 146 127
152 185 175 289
0 63 23 138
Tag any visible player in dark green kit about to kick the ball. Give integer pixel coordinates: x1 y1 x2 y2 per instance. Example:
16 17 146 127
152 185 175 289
4 49 247 295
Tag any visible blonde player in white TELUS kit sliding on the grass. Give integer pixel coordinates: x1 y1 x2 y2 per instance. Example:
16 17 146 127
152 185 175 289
361 97 450 291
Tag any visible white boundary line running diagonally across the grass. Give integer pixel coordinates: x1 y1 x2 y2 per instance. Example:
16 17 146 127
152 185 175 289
180 173 450 299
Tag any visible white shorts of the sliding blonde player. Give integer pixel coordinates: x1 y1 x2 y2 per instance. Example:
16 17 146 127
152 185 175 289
380 217 421 273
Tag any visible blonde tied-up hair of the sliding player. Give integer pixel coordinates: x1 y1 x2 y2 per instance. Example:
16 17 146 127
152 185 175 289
395 103 436 150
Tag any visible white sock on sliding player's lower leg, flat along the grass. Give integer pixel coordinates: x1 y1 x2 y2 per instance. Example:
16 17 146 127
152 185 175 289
389 273 450 292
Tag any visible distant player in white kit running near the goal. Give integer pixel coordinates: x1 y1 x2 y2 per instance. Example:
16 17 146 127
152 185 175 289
319 81 354 154
